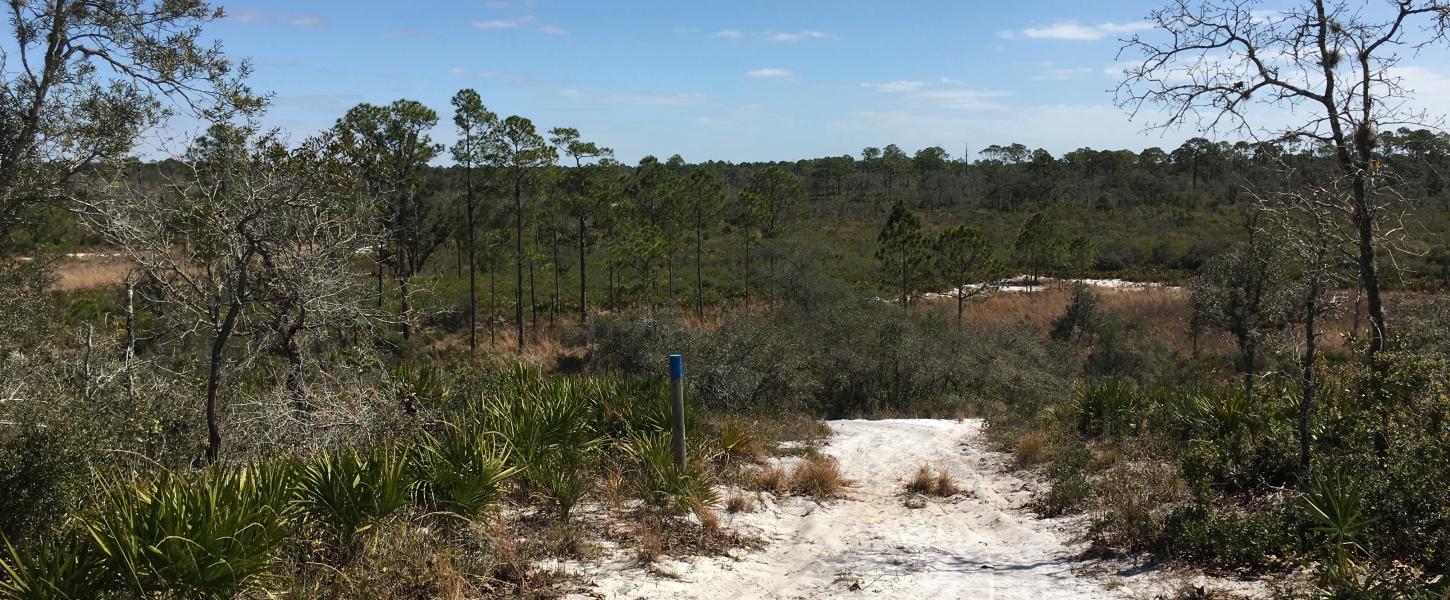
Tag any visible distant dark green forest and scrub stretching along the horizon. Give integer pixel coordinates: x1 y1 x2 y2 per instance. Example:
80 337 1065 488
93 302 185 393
14 129 1450 291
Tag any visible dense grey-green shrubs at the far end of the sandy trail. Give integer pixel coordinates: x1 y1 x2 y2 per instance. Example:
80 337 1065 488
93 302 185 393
583 265 1077 416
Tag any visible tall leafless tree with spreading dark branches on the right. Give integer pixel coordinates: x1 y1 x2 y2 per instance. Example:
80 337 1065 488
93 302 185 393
1117 0 1450 357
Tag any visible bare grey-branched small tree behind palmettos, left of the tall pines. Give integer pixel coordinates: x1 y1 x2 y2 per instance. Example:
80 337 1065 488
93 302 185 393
80 125 376 461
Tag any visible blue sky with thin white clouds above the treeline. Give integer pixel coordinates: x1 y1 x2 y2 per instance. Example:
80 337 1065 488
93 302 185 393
210 0 1450 162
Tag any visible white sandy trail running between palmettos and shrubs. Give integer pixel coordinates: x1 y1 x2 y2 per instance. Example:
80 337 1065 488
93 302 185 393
581 419 1171 600
